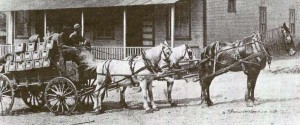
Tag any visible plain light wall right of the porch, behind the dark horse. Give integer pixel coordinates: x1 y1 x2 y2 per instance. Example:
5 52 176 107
207 0 300 46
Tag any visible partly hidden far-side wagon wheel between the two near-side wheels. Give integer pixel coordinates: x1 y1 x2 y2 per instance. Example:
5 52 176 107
20 86 46 110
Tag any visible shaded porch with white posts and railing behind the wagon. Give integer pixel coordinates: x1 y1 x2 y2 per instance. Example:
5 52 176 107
0 0 204 59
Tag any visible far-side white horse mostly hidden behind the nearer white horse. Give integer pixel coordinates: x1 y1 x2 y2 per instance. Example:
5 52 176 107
120 44 195 108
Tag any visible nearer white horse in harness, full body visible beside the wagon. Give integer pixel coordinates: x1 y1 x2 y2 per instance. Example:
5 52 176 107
83 42 172 114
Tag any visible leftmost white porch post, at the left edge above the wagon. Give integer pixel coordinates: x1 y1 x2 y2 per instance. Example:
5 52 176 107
6 11 15 51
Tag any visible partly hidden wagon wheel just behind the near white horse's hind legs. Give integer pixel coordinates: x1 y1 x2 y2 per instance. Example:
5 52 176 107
80 79 96 105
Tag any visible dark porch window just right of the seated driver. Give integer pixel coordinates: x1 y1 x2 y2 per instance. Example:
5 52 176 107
94 10 114 39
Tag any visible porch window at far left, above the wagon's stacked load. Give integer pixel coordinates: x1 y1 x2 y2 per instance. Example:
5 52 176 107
15 11 32 38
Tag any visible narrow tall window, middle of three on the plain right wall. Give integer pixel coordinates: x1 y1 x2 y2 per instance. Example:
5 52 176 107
259 7 267 33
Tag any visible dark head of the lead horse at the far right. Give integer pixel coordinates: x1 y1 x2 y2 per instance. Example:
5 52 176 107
280 23 296 56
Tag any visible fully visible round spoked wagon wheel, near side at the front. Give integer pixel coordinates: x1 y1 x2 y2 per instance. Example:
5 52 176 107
45 77 78 115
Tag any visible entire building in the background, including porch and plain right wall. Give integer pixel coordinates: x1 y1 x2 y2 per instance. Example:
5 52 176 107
0 0 300 59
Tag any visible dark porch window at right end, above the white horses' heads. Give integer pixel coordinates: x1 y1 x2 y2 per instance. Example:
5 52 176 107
166 0 191 39
